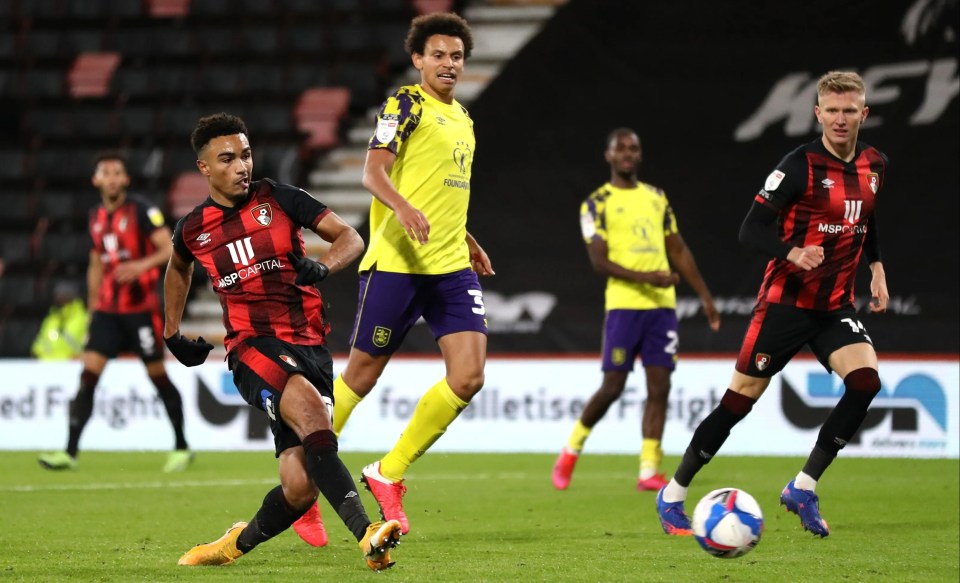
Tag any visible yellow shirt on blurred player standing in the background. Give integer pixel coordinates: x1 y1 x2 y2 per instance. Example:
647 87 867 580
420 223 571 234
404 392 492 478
580 182 677 311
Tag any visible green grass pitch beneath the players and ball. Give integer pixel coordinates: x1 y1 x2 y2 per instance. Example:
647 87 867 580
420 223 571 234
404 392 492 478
0 452 960 583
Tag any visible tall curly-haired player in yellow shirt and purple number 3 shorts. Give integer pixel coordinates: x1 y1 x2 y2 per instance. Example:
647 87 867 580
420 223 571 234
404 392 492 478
298 12 493 534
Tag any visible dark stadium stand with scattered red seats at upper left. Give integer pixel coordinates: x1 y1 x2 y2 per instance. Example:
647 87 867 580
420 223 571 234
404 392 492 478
0 0 464 356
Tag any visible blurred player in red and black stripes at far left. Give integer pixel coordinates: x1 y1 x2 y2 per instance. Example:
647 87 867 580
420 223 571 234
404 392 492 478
39 152 193 472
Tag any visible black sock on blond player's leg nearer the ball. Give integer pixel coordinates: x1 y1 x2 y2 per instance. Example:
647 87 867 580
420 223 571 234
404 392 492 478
673 389 757 488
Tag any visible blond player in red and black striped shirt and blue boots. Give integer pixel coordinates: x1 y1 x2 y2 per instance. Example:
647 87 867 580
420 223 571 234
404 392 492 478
657 71 890 537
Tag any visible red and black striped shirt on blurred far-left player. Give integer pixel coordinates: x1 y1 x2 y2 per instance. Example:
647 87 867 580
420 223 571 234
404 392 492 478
90 196 165 314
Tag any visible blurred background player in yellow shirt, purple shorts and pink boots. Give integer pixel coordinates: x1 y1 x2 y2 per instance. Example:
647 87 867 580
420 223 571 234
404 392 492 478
552 128 720 491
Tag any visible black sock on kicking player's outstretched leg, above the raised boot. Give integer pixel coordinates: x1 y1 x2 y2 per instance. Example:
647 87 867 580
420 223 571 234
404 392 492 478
303 429 370 541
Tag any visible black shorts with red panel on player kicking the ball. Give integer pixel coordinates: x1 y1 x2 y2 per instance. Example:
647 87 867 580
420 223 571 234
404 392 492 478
227 336 333 457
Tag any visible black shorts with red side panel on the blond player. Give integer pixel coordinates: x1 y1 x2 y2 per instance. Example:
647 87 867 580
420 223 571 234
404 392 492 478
737 301 873 378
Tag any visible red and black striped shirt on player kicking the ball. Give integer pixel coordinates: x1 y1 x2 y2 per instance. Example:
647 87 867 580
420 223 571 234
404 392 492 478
173 179 330 352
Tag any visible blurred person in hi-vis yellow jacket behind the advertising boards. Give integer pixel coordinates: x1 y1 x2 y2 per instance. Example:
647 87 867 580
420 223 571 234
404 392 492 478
30 282 88 360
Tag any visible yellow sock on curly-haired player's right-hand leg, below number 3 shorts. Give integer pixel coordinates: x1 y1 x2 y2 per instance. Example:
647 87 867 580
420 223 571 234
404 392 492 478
380 378 468 481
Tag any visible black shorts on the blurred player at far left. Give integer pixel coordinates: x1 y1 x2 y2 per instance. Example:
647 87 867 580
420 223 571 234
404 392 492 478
85 311 163 362
